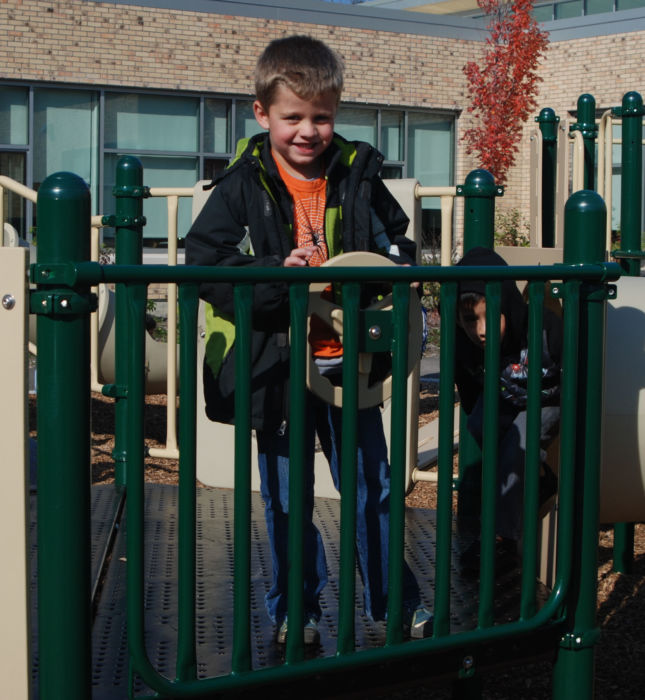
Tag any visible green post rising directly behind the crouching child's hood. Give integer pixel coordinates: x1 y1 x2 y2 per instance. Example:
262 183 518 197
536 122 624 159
457 169 504 533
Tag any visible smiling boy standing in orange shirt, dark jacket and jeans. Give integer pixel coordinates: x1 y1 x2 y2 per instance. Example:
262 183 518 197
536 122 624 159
186 36 429 644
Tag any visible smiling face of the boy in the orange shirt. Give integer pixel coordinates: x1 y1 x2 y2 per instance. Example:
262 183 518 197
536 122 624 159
253 85 337 178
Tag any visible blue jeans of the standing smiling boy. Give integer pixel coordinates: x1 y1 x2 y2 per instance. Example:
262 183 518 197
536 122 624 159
257 393 420 624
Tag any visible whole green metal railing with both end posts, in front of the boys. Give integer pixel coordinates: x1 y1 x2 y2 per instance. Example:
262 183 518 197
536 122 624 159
32 165 620 700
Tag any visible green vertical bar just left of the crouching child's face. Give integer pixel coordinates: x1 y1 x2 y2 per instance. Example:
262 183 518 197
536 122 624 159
434 282 457 637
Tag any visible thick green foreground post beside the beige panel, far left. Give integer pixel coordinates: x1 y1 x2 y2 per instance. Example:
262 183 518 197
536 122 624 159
32 173 92 700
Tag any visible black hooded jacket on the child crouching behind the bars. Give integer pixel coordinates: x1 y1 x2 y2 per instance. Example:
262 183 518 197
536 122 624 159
455 247 562 414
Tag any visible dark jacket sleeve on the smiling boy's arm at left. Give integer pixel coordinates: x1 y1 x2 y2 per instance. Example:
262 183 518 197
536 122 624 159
186 179 289 331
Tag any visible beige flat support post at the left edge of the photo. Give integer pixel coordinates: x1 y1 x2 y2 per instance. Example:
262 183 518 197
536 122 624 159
0 248 30 700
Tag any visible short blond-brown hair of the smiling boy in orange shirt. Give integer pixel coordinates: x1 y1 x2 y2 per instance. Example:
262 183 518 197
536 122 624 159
255 36 343 109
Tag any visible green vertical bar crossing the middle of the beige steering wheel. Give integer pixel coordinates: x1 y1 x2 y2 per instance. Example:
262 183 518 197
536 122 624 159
338 282 361 654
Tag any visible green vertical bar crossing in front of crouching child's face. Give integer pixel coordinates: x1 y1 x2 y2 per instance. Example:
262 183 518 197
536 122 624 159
478 282 502 628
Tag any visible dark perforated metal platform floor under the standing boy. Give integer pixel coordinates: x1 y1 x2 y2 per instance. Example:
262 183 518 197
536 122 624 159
31 484 544 700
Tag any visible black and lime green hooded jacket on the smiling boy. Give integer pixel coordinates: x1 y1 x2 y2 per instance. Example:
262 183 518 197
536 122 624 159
186 129 415 430
